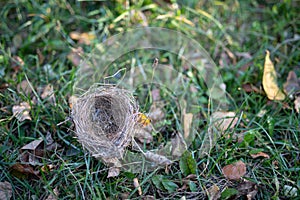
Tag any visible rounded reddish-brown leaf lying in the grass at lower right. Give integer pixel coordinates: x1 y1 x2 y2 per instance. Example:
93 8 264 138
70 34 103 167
222 161 246 180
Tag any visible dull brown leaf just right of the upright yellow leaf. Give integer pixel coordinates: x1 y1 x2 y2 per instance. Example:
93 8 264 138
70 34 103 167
283 71 300 98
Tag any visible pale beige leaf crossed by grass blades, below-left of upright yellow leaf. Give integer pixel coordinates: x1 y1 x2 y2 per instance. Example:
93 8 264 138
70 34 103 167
211 111 238 132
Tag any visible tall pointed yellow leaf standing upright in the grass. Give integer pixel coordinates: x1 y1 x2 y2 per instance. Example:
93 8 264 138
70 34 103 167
263 50 285 100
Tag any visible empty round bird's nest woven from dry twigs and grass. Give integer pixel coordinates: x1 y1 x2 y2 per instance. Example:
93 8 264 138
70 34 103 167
72 86 138 167
